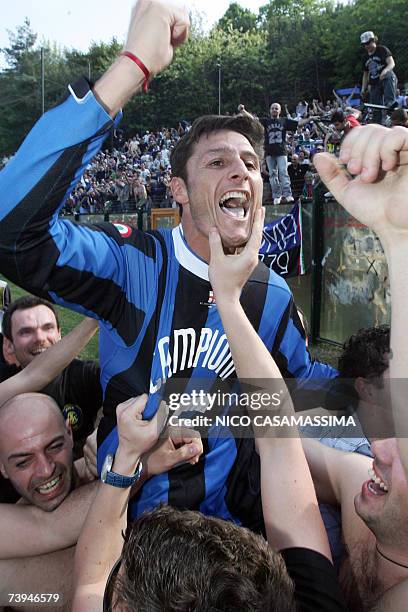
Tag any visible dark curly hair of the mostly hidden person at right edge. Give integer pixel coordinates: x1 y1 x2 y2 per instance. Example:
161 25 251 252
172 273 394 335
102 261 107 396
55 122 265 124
338 325 390 379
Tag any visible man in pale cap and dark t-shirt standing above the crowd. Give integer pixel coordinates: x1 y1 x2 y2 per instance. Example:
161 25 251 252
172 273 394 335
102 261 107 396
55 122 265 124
360 31 397 123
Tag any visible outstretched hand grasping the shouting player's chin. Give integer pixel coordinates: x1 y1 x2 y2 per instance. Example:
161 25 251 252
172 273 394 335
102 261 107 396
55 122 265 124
208 208 265 304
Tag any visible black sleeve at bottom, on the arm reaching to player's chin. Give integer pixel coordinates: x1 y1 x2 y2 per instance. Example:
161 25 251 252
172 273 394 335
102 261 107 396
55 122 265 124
280 548 347 612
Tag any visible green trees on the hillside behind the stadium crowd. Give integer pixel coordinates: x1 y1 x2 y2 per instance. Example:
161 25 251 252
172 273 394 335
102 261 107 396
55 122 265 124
0 0 408 154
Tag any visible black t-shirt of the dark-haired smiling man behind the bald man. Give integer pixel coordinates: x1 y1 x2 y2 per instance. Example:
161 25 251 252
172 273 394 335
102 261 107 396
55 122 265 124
0 359 103 503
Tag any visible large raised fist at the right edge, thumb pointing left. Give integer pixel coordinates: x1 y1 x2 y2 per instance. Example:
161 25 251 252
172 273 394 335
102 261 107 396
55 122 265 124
314 124 408 244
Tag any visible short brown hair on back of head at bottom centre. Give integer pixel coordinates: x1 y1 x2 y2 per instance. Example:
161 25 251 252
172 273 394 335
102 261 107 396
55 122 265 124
108 506 296 612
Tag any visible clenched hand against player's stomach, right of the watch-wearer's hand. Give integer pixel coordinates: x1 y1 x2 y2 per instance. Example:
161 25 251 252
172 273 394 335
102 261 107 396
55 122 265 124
142 426 203 478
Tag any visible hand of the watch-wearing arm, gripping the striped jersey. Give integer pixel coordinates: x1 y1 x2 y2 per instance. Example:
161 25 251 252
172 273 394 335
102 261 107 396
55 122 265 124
116 394 167 458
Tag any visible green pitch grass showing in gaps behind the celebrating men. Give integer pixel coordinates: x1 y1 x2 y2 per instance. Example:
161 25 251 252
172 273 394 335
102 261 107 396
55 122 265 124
0 275 341 367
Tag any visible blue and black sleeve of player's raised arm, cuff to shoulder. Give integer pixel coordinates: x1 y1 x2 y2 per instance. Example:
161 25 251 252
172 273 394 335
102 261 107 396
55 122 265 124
0 79 160 327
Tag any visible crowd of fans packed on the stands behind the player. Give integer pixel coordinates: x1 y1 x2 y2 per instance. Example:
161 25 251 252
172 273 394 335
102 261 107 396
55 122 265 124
0 90 408 210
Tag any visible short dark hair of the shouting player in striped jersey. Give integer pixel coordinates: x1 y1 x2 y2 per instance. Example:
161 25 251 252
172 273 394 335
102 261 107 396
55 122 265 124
170 115 264 183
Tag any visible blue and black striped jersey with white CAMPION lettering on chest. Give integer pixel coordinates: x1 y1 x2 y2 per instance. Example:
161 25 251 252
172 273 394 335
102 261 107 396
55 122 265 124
0 80 336 529
